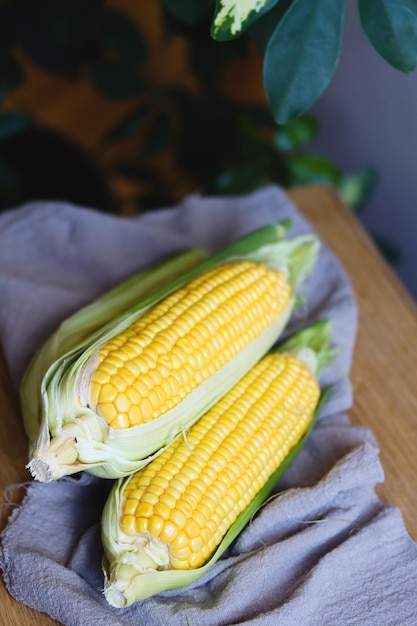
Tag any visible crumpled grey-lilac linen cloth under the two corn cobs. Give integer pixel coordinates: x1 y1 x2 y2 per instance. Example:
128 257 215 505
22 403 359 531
0 187 417 626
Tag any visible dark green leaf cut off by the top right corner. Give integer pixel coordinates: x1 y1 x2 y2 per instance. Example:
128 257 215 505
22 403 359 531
358 0 417 72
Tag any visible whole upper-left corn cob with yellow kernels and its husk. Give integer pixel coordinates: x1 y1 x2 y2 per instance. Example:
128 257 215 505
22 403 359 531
22 224 317 481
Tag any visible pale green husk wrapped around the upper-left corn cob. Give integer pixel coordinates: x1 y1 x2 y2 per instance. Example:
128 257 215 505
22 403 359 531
21 220 319 482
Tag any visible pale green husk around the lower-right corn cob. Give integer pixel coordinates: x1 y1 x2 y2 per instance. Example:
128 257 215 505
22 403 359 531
102 320 335 608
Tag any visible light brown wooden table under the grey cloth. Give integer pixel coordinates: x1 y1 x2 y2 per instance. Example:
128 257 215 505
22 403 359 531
0 187 417 626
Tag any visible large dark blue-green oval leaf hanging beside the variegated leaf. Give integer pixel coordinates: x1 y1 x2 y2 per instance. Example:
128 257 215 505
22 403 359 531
263 0 344 123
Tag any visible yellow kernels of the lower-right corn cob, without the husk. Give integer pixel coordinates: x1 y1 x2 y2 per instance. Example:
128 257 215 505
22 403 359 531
121 354 320 569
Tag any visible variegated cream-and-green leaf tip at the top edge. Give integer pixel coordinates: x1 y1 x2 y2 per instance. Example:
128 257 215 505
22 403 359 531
211 0 278 41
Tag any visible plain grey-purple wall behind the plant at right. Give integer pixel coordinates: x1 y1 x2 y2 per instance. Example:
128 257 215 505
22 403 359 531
313 1 417 299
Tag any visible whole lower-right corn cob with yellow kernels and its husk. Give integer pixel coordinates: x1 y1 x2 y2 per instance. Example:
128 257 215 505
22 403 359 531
102 322 331 607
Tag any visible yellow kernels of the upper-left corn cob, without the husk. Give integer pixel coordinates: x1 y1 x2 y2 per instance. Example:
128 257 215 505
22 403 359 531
89 261 291 428
